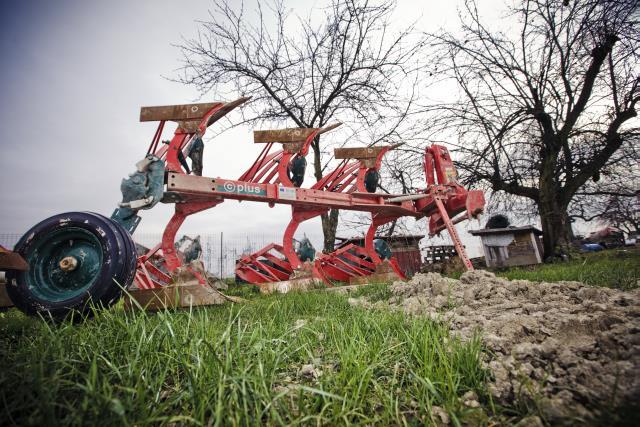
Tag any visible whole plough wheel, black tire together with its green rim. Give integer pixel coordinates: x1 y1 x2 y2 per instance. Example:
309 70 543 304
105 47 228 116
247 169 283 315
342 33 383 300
7 212 135 318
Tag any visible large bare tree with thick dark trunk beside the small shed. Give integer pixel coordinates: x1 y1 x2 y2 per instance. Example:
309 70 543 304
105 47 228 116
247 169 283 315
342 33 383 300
432 0 640 257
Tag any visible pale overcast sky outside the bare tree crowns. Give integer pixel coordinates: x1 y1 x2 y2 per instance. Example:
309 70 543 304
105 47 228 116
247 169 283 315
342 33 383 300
0 0 516 255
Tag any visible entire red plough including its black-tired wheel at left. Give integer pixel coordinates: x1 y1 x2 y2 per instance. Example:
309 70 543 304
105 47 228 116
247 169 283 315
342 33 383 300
8 98 484 316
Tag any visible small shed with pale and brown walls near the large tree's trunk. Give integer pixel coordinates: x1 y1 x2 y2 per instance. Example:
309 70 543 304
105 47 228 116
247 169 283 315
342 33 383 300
469 225 542 267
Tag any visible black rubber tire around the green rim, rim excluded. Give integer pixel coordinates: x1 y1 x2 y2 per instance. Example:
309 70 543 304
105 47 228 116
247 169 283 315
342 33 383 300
7 212 136 320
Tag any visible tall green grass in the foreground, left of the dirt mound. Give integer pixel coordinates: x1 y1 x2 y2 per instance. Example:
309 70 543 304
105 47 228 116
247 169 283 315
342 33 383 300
0 292 491 425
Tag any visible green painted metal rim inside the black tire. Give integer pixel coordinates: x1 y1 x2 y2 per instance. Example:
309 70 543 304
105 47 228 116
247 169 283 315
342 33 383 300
25 227 103 302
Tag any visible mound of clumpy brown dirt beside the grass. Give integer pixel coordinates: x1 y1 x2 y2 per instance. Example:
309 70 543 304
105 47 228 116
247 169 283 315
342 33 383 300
350 270 640 423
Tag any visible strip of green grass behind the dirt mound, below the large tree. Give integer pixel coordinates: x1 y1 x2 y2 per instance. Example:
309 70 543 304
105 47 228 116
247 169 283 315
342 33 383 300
496 249 640 290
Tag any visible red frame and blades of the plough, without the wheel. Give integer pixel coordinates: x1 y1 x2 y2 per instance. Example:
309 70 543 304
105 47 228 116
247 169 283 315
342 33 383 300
136 98 484 288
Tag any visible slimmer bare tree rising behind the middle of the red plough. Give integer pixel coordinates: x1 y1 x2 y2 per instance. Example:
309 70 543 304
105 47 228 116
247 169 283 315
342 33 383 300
176 0 423 251
